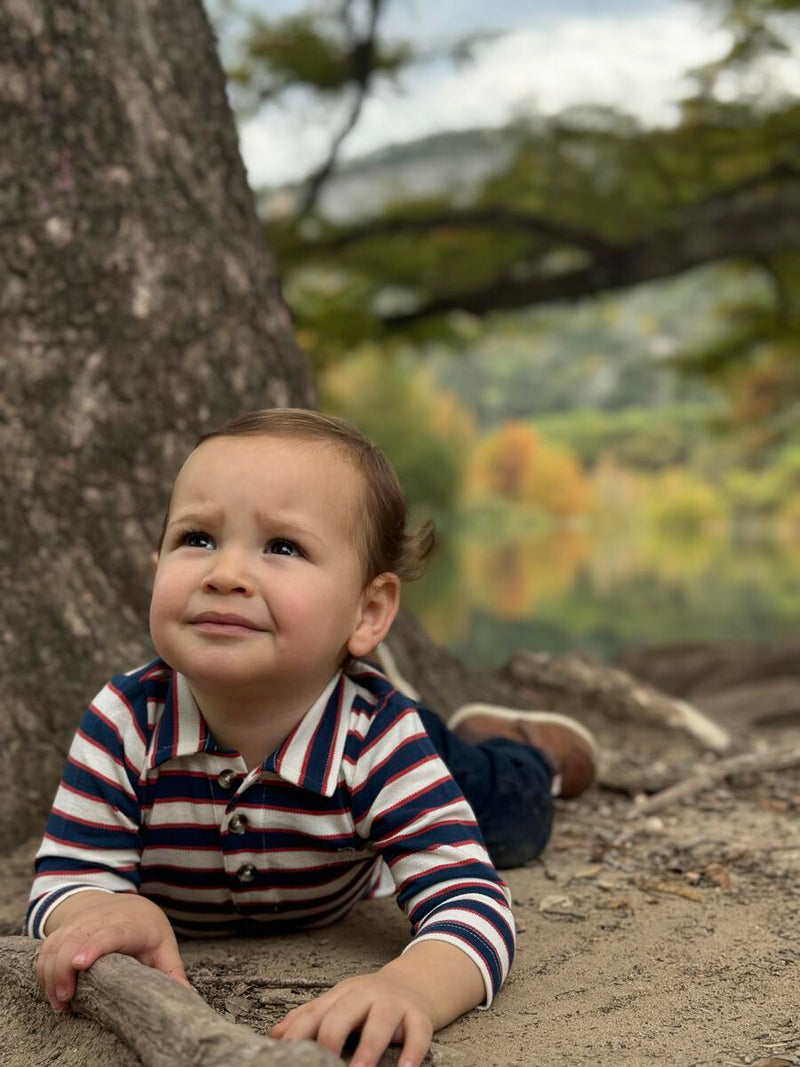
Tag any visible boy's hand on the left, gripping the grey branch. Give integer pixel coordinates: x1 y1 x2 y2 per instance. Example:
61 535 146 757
36 890 191 1012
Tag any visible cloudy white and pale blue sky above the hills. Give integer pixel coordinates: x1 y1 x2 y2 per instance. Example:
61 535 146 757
226 0 800 187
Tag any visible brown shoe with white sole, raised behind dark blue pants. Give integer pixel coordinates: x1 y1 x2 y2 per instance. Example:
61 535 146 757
447 704 599 797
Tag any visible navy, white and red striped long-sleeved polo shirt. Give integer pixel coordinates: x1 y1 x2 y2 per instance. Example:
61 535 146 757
26 659 514 1004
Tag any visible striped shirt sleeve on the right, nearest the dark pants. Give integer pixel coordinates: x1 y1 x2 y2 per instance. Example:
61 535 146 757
349 695 514 1006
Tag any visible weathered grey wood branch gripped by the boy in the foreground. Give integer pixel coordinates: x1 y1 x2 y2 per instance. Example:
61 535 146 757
0 937 341 1067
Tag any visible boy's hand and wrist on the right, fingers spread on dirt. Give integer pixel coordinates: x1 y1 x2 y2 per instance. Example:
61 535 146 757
270 941 485 1067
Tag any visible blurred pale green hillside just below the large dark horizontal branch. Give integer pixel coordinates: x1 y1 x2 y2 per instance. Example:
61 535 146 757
427 267 765 428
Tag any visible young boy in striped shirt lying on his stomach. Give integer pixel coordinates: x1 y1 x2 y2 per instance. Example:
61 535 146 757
27 409 594 1067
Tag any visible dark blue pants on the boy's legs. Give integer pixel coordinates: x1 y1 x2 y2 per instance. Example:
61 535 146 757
419 707 554 867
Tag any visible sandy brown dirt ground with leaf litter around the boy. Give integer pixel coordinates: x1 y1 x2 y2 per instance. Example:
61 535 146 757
0 687 800 1067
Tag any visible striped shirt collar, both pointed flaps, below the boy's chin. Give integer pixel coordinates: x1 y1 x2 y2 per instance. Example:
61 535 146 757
145 671 356 797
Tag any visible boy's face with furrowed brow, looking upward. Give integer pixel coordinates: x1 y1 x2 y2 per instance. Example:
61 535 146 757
150 436 386 702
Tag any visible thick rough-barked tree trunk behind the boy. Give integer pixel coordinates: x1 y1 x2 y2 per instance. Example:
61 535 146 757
0 0 314 848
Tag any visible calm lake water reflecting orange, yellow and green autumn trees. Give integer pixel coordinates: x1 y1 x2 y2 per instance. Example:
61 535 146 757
404 518 800 667
